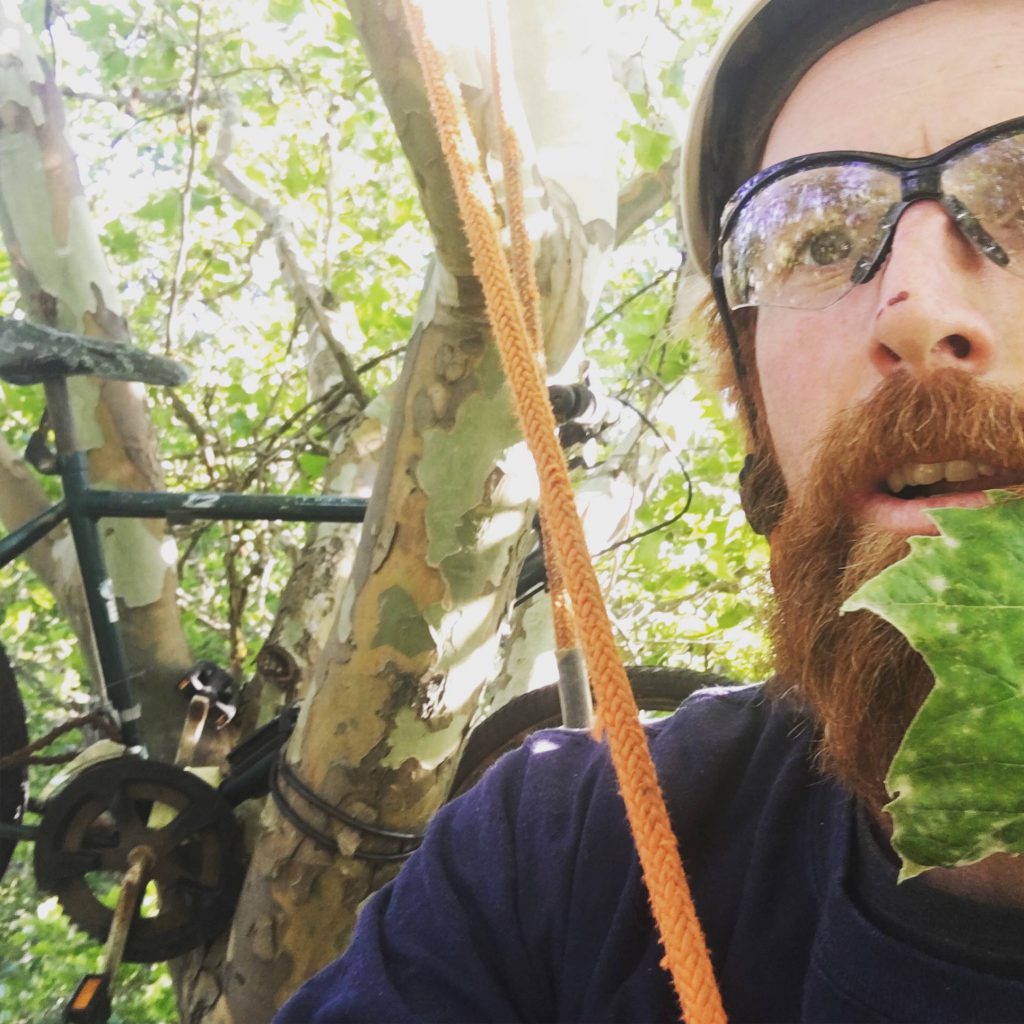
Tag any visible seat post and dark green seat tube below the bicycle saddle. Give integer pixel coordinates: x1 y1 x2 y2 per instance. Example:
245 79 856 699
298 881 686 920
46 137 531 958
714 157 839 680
44 377 144 753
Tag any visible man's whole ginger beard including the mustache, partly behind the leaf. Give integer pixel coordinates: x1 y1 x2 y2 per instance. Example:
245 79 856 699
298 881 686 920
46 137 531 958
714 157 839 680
768 370 1024 807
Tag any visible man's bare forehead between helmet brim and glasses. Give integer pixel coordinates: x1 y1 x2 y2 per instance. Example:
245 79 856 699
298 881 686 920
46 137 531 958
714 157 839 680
762 0 1024 166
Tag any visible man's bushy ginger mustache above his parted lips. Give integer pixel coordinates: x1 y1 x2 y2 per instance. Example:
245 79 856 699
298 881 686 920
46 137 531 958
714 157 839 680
796 368 1024 517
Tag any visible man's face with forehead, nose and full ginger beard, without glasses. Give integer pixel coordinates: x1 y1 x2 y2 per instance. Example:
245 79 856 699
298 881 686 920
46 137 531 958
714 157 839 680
755 0 1024 806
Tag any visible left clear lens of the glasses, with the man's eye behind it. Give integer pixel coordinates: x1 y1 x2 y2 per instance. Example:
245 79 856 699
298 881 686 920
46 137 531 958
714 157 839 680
722 163 901 309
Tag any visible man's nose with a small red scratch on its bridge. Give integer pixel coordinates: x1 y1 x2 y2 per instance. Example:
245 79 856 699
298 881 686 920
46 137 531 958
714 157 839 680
871 201 998 375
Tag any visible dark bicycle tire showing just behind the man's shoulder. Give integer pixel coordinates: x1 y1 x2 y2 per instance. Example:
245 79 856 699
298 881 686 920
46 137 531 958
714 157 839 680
449 666 735 800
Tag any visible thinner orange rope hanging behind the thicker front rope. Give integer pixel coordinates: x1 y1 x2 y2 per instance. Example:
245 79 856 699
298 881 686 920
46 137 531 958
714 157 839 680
487 0 577 650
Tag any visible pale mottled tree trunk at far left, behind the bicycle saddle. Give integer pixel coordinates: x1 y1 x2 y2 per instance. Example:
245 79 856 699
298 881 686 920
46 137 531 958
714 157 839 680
0 8 190 757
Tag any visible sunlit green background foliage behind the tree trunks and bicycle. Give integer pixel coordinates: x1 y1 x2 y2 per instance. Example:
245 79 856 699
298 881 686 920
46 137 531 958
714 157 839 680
0 0 766 1011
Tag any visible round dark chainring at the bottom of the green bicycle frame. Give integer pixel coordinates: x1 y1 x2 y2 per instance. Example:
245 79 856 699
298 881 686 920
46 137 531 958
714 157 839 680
35 757 245 964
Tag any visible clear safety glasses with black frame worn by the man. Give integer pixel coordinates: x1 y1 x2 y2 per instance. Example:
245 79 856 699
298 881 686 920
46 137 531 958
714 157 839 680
713 118 1024 309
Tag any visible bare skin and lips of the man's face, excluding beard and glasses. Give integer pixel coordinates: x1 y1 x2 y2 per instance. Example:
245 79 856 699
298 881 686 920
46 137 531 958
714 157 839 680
756 0 1024 537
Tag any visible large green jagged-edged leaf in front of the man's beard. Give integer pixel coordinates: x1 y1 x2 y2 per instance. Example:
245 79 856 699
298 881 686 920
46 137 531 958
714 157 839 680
843 492 1024 880
